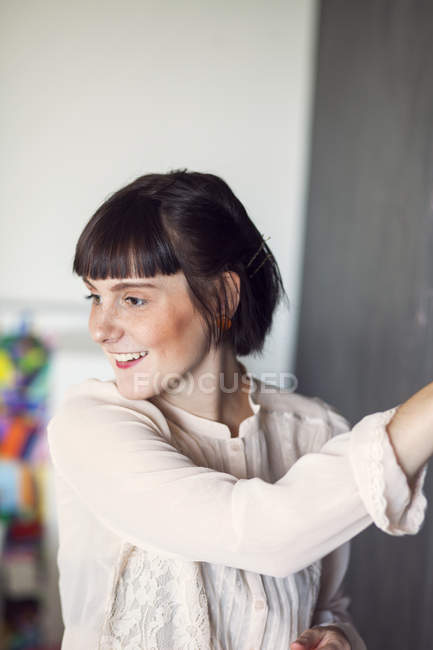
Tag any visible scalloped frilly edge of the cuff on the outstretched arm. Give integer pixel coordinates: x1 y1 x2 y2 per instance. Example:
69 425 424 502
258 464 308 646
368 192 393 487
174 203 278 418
369 407 427 535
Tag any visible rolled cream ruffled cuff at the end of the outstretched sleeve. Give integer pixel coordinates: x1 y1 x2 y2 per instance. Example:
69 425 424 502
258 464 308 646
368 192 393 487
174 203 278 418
349 404 427 535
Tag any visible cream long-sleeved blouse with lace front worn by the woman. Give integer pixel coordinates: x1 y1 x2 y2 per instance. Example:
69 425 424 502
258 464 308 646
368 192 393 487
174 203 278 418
48 373 427 650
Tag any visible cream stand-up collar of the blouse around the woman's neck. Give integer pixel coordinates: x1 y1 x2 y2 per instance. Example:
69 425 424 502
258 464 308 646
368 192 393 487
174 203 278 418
148 362 261 439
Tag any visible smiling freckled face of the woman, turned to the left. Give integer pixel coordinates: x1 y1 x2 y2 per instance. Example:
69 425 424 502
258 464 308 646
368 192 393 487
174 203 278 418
83 271 206 399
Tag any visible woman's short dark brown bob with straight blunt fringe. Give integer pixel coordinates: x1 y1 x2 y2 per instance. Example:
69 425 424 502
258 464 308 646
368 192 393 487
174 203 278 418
73 169 288 356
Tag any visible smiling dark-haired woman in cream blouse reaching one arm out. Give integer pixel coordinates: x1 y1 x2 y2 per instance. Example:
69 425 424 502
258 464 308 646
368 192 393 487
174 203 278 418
48 170 433 650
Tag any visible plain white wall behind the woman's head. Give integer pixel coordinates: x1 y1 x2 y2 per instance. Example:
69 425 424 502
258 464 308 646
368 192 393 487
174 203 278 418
0 0 316 384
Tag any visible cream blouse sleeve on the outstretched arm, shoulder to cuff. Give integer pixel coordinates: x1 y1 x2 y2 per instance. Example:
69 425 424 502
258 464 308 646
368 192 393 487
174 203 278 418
48 382 425 577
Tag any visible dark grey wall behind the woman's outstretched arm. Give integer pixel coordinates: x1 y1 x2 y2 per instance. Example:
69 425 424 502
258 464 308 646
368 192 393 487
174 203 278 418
295 0 433 650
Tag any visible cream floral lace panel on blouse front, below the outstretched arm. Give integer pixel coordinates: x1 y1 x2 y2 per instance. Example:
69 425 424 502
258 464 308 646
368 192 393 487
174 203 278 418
99 547 211 650
